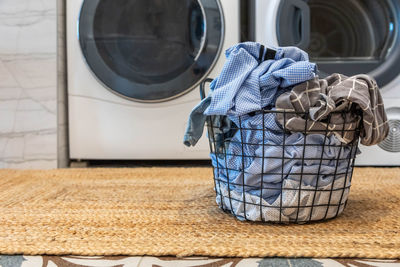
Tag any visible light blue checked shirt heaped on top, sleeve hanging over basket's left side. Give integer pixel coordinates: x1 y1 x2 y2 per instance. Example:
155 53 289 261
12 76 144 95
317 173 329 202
184 42 316 149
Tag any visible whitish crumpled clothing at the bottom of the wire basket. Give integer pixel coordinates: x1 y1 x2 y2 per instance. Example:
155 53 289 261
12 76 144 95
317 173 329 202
215 176 351 223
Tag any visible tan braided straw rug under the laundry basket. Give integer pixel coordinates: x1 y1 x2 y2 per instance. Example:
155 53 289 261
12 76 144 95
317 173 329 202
0 168 400 258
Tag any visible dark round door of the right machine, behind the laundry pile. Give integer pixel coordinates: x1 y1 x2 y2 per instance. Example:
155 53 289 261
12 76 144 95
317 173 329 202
276 0 400 86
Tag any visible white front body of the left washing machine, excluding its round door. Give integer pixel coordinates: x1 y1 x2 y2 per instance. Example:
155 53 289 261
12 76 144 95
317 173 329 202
67 0 240 160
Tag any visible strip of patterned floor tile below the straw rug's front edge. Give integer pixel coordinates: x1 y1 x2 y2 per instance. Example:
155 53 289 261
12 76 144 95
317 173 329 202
0 255 400 267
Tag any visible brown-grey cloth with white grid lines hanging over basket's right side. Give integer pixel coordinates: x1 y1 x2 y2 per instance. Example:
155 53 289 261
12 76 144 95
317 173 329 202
275 73 389 145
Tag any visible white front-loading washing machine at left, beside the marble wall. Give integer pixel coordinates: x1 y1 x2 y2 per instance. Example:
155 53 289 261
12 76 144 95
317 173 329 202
66 0 240 160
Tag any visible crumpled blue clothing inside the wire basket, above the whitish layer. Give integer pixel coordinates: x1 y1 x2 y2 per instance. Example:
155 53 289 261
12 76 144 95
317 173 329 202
210 113 357 205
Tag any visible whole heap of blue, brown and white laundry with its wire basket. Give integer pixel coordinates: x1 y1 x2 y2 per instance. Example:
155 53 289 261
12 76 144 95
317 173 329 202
184 42 388 222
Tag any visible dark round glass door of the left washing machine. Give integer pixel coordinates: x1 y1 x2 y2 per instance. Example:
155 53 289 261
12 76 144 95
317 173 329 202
78 0 223 102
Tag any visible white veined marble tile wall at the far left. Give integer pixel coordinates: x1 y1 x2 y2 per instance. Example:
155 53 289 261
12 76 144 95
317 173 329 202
0 0 57 168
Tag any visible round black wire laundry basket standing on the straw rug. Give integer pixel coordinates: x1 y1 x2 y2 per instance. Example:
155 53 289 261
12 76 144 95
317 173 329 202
200 79 361 223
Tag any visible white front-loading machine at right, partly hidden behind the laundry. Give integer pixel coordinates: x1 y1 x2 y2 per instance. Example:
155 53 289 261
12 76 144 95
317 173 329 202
253 0 400 166
